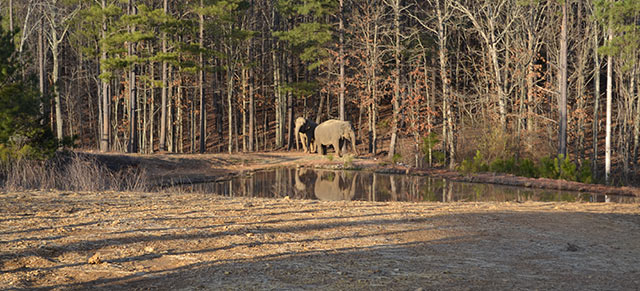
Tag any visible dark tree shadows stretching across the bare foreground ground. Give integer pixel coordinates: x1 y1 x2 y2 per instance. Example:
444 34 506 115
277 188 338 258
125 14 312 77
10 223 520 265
3 211 640 290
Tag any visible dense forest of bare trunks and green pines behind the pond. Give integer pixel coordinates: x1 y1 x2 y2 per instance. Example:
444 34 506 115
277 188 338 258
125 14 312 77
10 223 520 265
0 0 640 185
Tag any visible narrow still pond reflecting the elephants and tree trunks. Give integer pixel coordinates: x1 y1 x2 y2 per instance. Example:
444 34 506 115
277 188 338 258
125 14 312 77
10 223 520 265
165 167 640 203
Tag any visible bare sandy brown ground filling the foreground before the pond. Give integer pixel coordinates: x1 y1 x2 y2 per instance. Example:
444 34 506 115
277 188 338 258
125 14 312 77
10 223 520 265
0 191 640 290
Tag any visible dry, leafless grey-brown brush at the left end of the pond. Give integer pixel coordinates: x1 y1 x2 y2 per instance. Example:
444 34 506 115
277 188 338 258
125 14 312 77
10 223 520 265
3 152 147 191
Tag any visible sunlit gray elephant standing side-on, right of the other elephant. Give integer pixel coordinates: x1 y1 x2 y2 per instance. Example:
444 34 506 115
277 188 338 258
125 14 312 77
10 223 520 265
314 119 358 157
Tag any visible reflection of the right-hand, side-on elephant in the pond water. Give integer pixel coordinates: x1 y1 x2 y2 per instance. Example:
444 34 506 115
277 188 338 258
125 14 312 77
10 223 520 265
314 171 358 201
